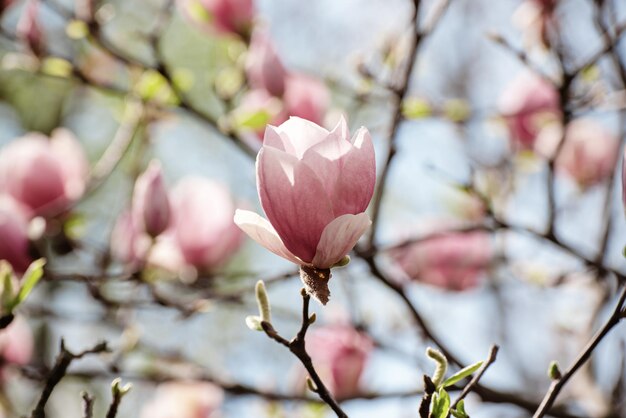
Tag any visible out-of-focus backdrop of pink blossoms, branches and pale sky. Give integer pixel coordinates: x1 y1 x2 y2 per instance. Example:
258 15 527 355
0 0 626 418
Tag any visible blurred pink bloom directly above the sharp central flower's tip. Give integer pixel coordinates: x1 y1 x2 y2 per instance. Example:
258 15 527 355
283 74 330 125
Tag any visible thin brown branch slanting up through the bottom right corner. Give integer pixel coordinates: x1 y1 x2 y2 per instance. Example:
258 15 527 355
533 286 626 418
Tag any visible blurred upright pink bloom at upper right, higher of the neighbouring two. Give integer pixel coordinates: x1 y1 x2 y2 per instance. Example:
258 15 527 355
498 73 561 150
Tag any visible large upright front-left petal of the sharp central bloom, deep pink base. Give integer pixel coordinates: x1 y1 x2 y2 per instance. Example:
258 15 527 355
257 147 334 262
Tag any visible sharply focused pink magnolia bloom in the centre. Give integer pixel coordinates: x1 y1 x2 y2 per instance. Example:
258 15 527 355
235 118 376 269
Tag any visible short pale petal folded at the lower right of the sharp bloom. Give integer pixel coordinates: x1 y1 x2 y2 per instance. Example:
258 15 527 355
312 213 372 268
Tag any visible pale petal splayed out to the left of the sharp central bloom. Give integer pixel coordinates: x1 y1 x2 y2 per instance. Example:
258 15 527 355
235 209 302 264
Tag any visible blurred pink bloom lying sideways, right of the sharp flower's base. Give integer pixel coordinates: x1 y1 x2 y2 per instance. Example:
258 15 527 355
391 232 492 291
